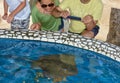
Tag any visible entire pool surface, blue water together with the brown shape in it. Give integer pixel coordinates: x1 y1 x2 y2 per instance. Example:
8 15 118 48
0 38 120 83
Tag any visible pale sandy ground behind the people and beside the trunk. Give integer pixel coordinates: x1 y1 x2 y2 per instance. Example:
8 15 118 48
0 0 120 41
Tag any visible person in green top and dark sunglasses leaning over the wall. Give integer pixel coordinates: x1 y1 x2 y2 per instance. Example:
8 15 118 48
30 0 63 31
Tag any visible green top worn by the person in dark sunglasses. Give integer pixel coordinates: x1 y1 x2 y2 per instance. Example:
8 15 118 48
31 0 61 31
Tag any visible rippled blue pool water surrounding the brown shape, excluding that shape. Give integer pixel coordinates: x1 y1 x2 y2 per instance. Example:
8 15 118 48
0 38 120 83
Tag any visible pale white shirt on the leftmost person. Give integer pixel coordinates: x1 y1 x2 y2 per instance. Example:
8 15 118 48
6 0 31 20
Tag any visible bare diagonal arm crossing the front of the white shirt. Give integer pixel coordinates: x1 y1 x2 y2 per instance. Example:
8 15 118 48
7 0 27 23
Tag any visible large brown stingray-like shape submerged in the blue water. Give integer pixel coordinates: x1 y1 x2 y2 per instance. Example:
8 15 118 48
32 54 78 82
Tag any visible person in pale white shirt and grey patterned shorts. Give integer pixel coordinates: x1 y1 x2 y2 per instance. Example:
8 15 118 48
2 0 30 30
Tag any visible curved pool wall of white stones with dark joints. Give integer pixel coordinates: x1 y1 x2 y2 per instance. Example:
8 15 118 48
0 30 120 62
